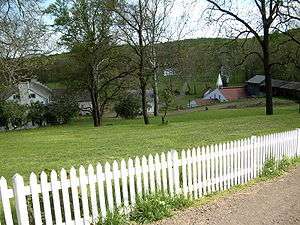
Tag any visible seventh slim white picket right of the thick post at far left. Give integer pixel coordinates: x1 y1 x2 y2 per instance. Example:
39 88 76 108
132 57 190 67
88 164 99 222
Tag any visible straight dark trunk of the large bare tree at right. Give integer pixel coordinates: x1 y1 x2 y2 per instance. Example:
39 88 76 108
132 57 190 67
262 29 273 115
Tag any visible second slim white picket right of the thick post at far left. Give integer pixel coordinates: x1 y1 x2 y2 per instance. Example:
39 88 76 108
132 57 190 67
41 171 53 225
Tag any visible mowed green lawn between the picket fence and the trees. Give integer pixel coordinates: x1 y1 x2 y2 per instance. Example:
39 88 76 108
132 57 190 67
0 105 300 184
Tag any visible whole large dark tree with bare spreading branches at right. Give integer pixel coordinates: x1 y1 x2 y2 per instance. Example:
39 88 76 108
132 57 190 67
206 0 300 115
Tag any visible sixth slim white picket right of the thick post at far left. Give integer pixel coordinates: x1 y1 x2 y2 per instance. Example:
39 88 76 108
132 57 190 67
79 166 92 225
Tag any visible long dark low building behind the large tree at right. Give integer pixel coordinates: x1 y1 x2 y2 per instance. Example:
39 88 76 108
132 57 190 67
246 75 300 99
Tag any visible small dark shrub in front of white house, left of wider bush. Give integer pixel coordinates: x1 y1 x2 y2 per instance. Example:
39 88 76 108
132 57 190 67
27 102 47 126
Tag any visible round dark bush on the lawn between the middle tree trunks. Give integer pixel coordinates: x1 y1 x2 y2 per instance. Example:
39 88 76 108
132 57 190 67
114 95 141 119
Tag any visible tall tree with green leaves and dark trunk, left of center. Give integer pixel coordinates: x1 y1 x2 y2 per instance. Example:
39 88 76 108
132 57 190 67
48 0 130 127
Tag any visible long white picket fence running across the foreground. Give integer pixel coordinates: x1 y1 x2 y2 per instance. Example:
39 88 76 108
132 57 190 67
0 129 300 225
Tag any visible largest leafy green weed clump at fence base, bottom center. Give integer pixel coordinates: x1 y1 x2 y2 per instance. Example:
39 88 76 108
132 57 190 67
130 193 191 224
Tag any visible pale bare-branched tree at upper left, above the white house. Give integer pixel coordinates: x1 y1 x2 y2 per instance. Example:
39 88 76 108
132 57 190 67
0 0 53 86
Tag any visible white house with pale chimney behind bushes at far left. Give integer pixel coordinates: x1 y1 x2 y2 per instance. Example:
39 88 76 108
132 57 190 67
0 79 52 105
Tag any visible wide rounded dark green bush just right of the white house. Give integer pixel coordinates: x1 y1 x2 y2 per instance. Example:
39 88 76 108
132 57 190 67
45 95 79 124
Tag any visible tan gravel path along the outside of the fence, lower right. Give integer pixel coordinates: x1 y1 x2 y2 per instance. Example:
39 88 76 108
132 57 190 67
154 166 300 225
